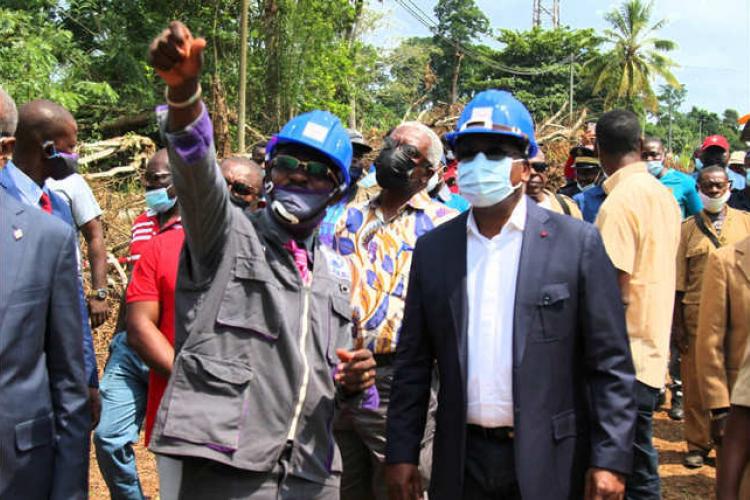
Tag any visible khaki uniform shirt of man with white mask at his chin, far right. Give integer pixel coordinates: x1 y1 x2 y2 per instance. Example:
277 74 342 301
677 207 750 305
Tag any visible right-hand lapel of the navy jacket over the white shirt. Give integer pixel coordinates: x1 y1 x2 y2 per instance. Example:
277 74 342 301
513 200 555 366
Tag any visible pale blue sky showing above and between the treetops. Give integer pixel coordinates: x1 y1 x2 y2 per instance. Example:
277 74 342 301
366 0 750 115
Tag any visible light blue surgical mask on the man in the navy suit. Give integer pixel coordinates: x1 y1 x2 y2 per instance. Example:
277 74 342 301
458 153 522 208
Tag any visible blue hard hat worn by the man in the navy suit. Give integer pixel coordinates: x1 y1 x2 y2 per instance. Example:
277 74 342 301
447 89 539 158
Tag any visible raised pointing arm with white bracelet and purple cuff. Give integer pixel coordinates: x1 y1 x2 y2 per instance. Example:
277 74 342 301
149 21 232 281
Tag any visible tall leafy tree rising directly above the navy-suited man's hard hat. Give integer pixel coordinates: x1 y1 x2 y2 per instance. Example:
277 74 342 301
434 0 490 104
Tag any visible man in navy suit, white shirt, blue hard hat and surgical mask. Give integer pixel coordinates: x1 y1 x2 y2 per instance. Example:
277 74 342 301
386 90 636 500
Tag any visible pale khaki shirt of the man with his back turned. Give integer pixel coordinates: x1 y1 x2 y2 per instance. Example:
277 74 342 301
596 162 682 388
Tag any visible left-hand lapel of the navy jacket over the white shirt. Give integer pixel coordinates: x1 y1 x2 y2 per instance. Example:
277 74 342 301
441 211 469 387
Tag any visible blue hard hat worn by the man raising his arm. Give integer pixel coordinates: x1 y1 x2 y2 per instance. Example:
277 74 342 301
267 109 352 186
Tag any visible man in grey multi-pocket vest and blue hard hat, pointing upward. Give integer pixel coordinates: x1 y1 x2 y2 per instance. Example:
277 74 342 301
149 21 377 500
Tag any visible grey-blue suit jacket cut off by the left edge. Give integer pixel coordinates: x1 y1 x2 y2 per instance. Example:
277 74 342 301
0 189 90 500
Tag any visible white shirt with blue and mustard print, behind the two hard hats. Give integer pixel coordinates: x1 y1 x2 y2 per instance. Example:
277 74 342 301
333 191 458 354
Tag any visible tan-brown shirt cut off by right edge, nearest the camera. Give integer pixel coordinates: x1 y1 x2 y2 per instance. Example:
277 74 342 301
696 238 750 410
